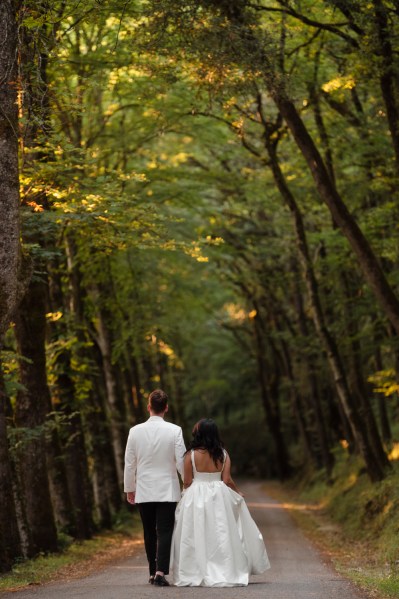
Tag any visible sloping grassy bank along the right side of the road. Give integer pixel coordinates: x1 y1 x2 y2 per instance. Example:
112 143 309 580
272 451 399 599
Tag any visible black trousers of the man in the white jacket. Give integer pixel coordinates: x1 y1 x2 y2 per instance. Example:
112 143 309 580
137 501 176 576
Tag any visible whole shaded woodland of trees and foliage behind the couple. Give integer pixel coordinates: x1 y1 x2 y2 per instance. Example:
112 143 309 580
0 0 399 571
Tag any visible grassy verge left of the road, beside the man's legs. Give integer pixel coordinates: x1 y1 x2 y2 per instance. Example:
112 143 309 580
0 510 142 592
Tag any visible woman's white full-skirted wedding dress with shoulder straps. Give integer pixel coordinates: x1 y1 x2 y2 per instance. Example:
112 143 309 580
170 451 270 587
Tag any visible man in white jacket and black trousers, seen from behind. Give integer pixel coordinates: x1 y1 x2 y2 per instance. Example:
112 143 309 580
125 389 186 586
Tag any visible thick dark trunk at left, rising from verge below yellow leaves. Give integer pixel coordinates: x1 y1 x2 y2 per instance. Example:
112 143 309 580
15 280 57 553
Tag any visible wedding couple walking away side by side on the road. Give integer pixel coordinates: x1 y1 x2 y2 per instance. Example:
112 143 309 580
125 389 270 587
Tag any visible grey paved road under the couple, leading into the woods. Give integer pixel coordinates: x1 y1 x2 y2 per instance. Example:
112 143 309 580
1 483 366 599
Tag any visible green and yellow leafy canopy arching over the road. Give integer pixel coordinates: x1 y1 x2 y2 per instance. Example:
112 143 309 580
5 0 399 520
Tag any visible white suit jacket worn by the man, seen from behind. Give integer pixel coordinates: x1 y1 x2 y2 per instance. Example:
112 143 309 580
125 416 186 503
